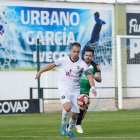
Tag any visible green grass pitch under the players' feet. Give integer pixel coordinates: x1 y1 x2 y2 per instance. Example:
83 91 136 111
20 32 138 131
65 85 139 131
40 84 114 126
0 110 140 140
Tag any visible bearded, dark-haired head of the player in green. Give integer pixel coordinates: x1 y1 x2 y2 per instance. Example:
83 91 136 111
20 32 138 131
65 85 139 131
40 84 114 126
84 48 94 64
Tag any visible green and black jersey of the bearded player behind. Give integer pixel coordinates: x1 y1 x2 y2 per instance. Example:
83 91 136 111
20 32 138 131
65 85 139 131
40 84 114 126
80 62 101 94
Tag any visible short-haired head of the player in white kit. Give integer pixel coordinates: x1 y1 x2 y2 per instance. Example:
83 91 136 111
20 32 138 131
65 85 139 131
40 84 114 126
70 42 81 61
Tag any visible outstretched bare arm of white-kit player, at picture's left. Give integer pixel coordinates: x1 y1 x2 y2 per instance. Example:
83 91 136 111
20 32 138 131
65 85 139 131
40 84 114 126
35 63 56 79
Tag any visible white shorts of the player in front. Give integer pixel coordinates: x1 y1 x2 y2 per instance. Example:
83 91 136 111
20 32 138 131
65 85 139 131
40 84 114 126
59 88 80 113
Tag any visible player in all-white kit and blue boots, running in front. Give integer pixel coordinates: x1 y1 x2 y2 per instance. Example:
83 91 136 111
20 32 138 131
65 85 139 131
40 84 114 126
36 42 96 138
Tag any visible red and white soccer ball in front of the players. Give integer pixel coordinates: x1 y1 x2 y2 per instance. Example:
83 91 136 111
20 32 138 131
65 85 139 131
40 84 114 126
77 94 90 110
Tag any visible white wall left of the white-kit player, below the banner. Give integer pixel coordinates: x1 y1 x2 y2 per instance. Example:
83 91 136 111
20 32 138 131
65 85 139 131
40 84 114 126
0 71 59 100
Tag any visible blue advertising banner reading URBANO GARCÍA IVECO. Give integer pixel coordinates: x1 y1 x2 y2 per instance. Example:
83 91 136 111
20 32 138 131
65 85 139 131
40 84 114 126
0 6 112 70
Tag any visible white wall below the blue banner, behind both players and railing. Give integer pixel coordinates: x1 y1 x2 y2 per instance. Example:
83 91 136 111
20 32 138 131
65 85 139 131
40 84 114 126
0 67 140 100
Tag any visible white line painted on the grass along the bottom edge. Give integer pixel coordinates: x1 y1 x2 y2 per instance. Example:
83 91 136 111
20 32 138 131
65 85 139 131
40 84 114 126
0 136 140 139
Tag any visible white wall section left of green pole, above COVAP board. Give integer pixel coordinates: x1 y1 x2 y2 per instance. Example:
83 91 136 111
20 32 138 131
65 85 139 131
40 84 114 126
0 72 36 100
